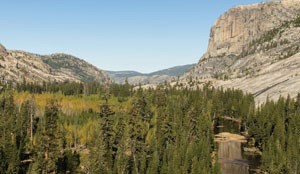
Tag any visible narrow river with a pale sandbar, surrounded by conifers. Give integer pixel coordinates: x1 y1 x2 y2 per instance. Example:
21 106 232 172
215 117 260 174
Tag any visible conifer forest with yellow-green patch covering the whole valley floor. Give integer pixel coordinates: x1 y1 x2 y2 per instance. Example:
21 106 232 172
0 83 300 174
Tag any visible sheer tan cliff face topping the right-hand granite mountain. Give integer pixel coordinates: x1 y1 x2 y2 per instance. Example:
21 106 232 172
206 0 300 57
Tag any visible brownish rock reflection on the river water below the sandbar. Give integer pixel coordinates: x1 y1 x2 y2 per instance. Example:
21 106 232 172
218 141 249 174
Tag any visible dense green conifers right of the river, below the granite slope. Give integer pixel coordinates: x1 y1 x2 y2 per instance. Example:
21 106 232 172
248 95 300 173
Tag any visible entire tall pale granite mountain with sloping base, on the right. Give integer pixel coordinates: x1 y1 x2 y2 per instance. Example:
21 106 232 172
181 0 300 103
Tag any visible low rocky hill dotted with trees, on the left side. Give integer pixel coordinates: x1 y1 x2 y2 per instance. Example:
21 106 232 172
0 45 110 84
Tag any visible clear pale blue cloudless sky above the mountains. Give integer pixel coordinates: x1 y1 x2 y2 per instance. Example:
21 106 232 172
0 0 261 73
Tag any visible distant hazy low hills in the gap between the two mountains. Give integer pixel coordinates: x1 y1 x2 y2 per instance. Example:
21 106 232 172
106 64 195 85
